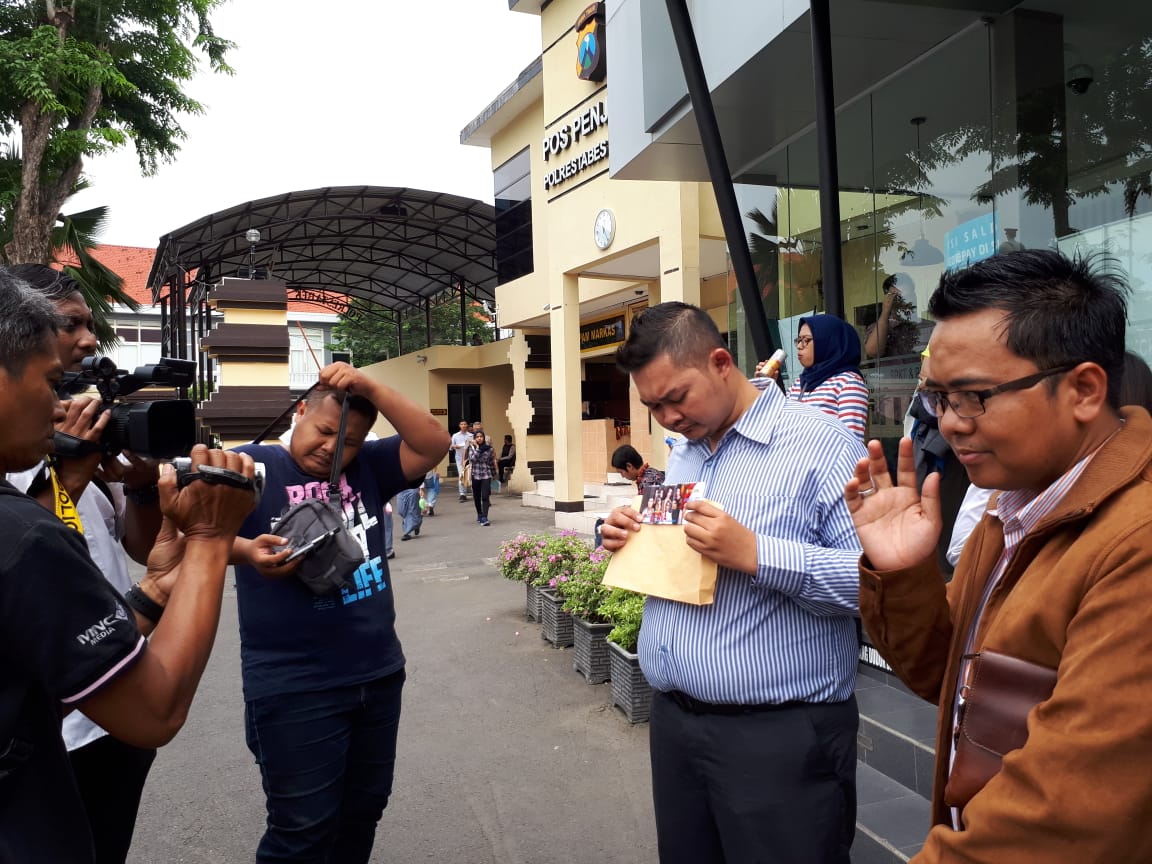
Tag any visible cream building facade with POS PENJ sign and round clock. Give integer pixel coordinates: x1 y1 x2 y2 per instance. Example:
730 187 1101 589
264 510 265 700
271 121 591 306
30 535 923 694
461 0 734 525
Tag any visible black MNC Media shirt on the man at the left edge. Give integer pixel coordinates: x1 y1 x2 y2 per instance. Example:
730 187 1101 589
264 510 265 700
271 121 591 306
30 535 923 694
0 480 144 864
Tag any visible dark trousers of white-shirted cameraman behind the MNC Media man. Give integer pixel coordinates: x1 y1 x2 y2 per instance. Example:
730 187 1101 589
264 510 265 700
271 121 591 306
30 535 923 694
68 735 156 864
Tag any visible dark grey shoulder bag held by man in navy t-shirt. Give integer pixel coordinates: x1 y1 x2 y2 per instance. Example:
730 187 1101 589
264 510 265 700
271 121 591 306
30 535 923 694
253 385 364 594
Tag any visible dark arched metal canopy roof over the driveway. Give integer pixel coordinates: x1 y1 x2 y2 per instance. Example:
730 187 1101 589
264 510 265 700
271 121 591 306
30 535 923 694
147 185 497 317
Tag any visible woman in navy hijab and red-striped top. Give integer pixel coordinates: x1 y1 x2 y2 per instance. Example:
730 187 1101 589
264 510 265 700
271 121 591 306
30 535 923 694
757 314 867 441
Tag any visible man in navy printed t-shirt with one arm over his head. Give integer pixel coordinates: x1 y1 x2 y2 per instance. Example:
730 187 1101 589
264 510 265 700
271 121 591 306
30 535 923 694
233 363 448 864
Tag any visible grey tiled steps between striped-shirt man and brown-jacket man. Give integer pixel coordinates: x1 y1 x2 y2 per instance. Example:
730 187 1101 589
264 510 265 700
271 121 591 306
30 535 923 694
852 664 937 864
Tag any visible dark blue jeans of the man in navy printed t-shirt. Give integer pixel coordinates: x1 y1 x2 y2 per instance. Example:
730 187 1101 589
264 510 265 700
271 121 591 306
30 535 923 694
244 669 404 864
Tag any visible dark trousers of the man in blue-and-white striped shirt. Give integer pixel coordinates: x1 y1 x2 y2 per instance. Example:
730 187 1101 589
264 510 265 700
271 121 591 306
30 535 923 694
649 692 859 864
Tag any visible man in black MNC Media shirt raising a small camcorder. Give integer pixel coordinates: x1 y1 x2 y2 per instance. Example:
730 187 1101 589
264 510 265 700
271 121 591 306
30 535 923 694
0 268 255 864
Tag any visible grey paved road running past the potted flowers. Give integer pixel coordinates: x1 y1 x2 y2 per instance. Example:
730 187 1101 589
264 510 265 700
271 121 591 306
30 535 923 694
129 493 657 864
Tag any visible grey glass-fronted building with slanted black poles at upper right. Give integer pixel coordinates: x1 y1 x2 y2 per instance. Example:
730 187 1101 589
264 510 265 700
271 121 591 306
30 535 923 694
607 0 1152 437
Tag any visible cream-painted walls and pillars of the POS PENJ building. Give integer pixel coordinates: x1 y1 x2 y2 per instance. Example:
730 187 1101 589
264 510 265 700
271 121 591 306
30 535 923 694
476 0 727 507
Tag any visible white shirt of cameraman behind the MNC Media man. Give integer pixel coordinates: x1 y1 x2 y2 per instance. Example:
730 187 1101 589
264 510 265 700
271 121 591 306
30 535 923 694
7 464 132 750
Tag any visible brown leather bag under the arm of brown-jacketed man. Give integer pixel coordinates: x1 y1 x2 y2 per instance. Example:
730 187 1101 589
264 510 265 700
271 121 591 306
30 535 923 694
943 651 1056 810
